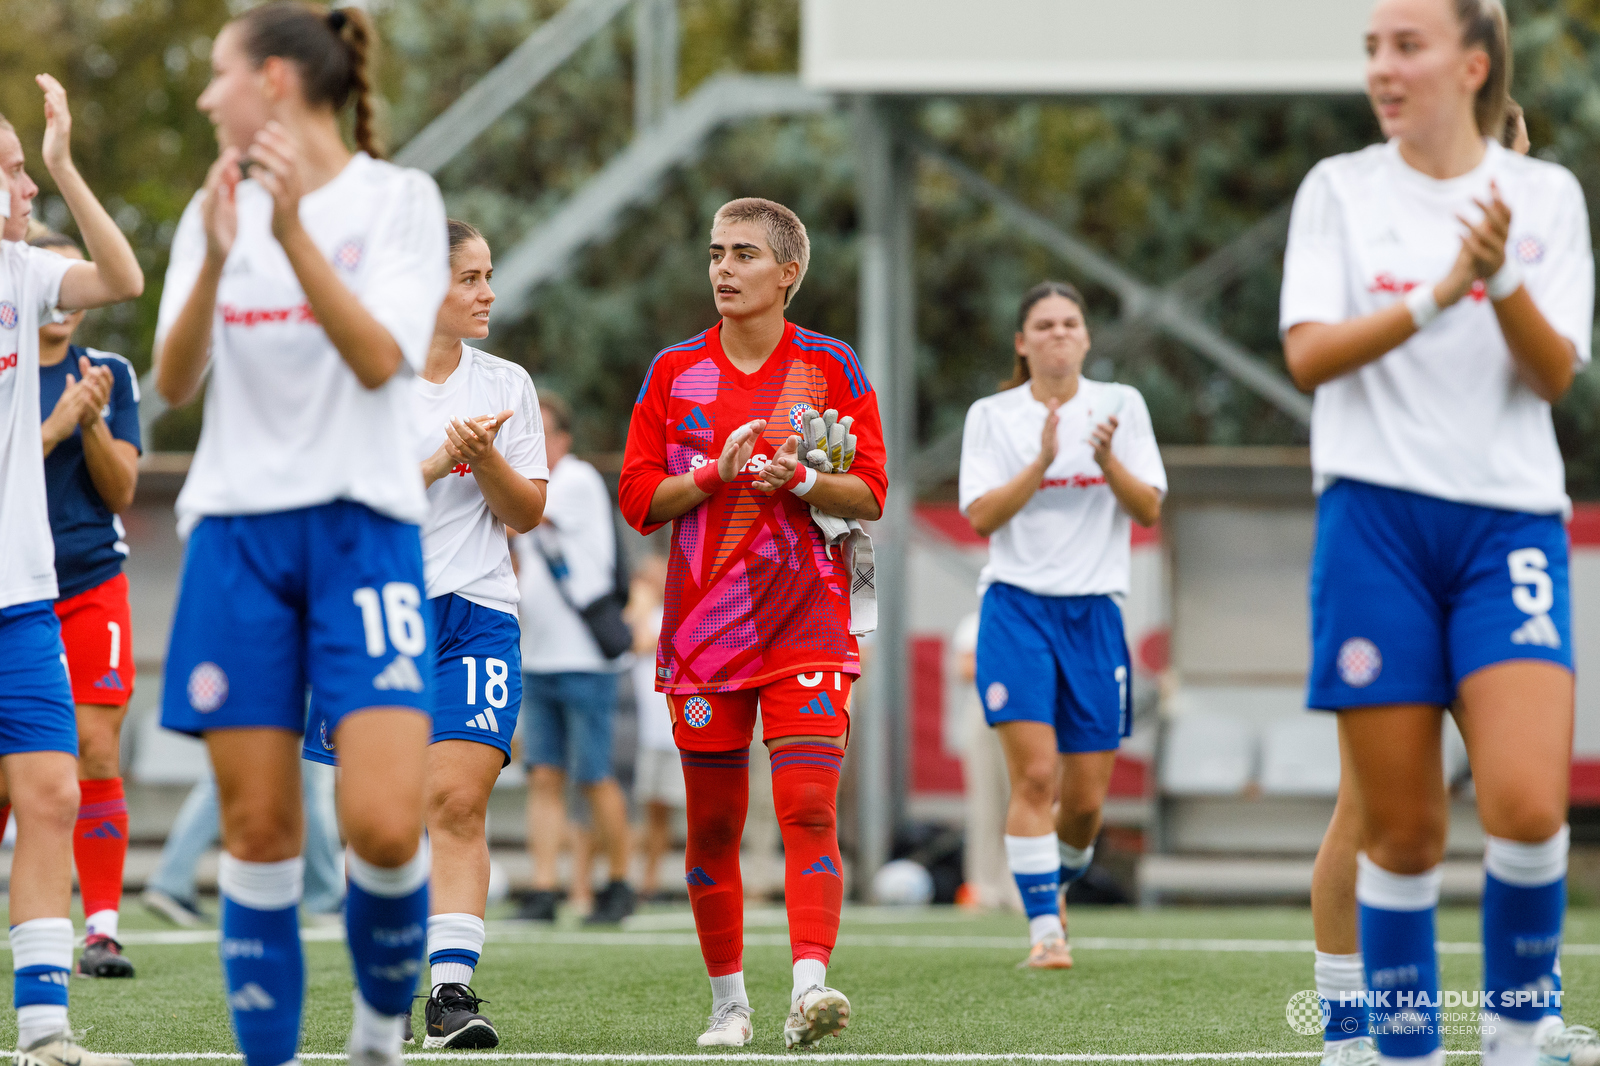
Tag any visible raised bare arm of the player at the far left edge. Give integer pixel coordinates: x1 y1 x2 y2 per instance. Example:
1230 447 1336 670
34 74 144 311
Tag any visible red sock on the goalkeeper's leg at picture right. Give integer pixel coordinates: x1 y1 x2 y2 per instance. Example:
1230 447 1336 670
773 744 845 965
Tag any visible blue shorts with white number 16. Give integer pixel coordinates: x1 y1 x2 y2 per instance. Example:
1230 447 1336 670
162 499 434 736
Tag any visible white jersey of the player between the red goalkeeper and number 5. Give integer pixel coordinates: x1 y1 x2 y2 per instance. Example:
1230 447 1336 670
960 378 1166 595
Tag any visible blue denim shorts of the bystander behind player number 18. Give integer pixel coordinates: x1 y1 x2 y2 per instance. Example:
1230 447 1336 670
522 671 616 784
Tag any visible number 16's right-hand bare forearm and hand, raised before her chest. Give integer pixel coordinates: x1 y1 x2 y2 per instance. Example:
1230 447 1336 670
250 122 405 389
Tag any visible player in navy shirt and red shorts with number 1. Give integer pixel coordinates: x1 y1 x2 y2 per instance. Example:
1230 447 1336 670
29 234 139 976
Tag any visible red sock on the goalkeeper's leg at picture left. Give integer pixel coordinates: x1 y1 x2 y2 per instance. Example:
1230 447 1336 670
678 747 750 976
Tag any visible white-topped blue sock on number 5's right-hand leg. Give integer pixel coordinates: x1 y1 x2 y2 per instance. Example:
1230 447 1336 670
1483 826 1568 1021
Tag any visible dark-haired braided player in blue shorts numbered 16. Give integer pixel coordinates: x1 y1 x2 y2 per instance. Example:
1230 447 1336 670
155 2 450 1066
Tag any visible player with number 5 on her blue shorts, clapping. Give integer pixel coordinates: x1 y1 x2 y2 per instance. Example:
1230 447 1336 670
1280 0 1594 1066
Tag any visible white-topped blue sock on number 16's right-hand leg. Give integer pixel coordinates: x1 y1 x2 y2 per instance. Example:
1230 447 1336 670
344 844 427 1016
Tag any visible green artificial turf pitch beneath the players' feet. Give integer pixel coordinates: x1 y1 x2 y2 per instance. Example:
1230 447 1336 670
0 908 1600 1058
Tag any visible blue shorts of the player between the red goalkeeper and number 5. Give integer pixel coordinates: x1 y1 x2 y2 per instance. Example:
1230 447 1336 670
978 583 1133 754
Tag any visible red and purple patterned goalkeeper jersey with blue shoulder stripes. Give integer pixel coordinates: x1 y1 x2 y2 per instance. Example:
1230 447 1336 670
618 323 888 693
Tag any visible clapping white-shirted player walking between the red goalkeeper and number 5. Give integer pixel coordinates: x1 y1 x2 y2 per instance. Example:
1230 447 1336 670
960 282 1166 970
